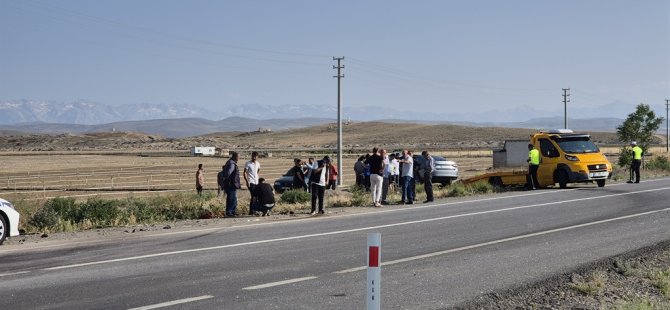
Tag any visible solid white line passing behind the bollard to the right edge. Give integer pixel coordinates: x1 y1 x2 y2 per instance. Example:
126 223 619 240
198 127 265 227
333 208 670 274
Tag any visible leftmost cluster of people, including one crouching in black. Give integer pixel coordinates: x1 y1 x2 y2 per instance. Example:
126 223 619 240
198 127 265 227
195 151 275 217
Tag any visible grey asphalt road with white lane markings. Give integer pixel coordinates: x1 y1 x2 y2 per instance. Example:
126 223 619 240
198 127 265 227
0 179 670 309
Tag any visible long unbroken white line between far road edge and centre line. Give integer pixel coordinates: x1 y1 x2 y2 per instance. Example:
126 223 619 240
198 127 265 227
42 187 670 270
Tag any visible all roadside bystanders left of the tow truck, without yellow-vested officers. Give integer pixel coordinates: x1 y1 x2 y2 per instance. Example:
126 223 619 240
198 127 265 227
196 147 435 217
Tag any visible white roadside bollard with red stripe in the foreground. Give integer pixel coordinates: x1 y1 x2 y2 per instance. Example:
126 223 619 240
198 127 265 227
365 233 382 310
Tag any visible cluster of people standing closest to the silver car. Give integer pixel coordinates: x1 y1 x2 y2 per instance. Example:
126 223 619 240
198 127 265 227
354 147 435 207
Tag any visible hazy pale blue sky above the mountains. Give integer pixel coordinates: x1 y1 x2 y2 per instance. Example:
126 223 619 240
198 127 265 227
0 0 670 117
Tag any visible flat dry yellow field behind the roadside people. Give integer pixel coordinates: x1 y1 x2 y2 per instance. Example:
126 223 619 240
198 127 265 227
0 153 491 200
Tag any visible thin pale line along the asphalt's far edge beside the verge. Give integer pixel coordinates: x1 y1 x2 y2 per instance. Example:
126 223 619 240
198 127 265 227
3 178 670 253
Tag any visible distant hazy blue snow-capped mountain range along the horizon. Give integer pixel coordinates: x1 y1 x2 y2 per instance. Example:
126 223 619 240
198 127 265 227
0 99 665 125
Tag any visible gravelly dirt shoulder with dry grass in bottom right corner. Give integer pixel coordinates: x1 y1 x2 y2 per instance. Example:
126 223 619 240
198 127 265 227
455 240 670 310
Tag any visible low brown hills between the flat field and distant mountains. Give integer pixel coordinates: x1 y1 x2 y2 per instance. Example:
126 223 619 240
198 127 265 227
0 122 619 151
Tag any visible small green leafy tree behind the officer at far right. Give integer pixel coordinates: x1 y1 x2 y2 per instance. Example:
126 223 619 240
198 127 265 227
616 103 664 159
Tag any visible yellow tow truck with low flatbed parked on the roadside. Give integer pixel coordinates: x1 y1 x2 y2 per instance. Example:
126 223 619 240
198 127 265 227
463 129 612 188
